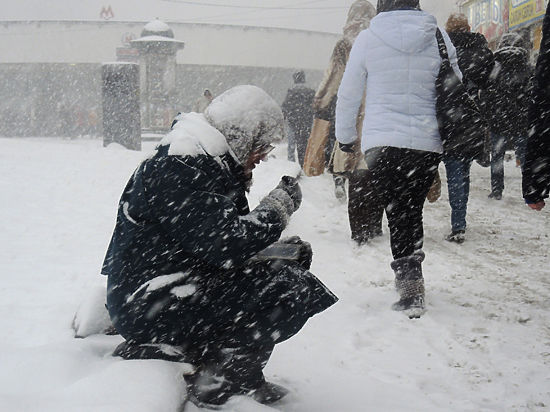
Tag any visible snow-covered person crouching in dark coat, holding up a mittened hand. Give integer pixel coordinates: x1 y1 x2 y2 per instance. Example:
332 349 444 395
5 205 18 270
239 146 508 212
102 86 337 405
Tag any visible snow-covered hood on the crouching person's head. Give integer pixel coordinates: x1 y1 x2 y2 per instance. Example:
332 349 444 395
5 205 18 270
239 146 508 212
204 85 285 163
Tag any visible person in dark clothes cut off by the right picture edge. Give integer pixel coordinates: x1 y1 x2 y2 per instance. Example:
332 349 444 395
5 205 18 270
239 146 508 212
523 1 550 210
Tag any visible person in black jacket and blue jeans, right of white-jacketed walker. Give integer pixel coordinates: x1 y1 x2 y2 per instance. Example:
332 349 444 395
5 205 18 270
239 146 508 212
443 13 494 243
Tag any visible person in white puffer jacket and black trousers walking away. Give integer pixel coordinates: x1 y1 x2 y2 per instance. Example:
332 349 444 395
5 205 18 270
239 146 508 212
336 0 462 317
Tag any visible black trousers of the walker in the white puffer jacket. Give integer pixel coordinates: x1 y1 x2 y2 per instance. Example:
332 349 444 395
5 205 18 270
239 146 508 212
365 146 441 259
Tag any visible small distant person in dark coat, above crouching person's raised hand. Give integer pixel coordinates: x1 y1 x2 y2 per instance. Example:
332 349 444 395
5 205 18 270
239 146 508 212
282 70 315 167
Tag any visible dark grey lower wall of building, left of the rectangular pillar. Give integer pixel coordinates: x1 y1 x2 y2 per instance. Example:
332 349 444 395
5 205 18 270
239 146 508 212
0 63 101 137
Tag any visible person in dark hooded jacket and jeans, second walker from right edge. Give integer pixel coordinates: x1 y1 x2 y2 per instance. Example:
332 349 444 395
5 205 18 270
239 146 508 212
482 32 532 200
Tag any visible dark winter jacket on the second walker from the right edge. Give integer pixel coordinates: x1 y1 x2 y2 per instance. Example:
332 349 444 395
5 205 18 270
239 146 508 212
482 46 532 138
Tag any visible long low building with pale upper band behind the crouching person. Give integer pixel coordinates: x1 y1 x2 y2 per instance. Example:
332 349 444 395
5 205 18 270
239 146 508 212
0 21 338 137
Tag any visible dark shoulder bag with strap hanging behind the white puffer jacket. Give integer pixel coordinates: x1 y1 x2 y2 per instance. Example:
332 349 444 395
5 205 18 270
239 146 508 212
435 29 487 160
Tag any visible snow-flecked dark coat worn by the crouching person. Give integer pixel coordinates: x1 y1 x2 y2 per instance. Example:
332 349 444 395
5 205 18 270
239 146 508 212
102 134 337 350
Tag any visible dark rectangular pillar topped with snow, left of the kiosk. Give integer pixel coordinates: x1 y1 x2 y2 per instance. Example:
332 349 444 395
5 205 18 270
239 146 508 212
101 63 141 150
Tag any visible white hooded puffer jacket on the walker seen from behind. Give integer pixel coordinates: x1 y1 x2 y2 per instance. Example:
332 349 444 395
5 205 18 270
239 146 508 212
336 10 462 153
